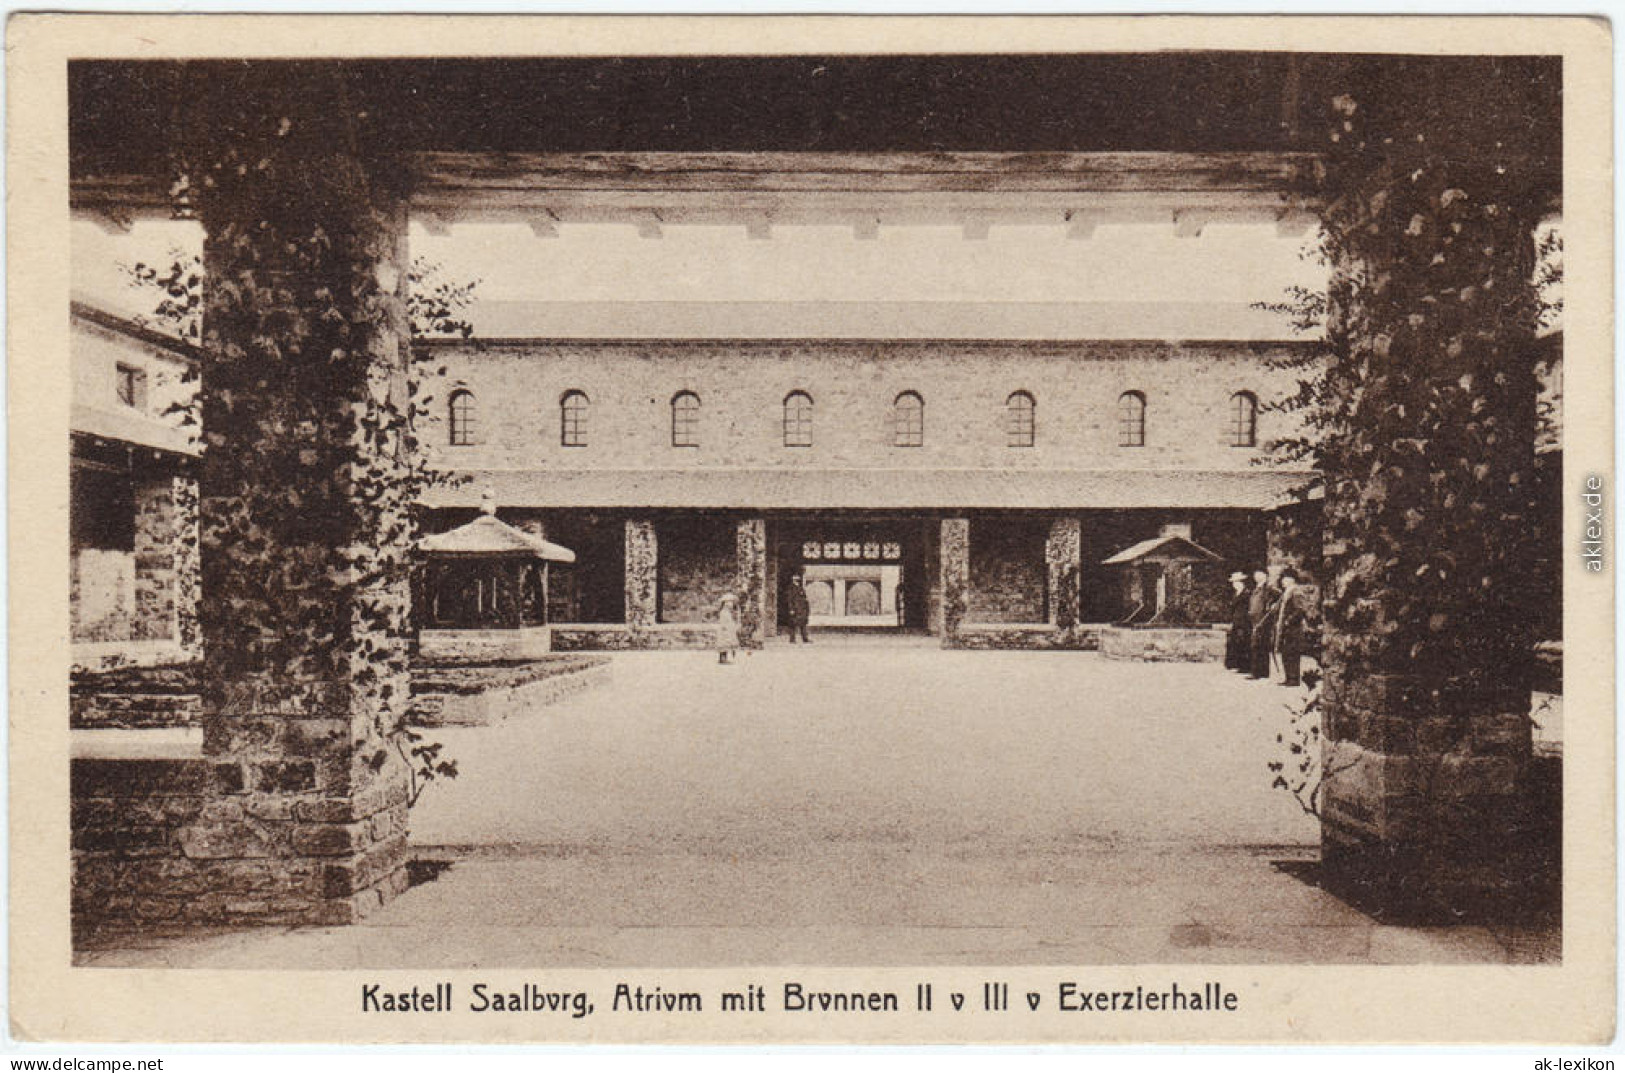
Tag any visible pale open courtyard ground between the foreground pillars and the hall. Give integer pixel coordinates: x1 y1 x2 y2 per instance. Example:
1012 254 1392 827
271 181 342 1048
80 650 1557 967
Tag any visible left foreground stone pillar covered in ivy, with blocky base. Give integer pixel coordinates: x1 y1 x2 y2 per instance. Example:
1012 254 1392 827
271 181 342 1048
179 77 414 922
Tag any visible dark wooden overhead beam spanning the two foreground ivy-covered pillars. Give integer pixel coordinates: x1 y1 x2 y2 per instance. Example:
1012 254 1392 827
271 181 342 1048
68 52 1562 208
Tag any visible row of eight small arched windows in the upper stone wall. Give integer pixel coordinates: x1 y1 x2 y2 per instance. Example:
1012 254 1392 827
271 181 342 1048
450 389 1258 447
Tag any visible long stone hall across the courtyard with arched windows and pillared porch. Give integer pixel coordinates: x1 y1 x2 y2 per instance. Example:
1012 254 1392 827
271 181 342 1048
427 331 1310 649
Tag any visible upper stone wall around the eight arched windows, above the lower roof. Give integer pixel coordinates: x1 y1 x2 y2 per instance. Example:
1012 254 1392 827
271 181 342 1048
426 340 1302 470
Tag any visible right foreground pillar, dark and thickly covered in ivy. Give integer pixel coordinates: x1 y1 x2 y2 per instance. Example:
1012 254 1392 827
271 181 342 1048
1300 72 1555 920
